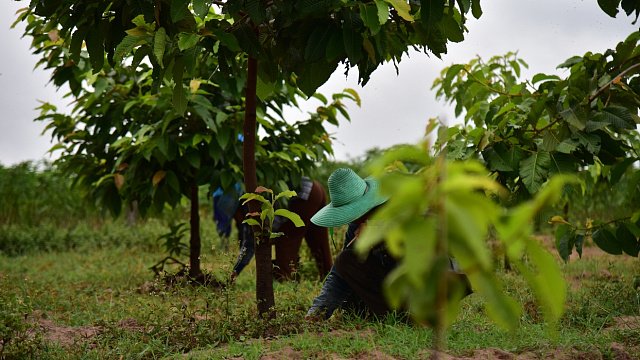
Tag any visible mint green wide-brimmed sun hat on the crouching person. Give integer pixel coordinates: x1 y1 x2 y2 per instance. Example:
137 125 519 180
311 168 387 227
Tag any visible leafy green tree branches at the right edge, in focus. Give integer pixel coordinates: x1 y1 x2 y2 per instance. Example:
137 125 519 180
434 28 640 260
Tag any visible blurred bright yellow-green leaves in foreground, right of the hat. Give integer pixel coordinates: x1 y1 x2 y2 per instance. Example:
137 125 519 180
358 141 569 329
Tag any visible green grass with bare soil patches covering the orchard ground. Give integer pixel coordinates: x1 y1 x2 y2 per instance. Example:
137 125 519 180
0 224 640 359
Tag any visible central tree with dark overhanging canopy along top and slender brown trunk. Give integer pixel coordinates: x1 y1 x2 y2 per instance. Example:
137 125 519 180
21 0 481 316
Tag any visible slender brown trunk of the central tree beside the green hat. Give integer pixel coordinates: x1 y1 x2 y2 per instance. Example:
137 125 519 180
242 57 275 319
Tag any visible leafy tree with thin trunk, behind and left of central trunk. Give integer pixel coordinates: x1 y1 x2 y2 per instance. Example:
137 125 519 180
23 9 359 280
